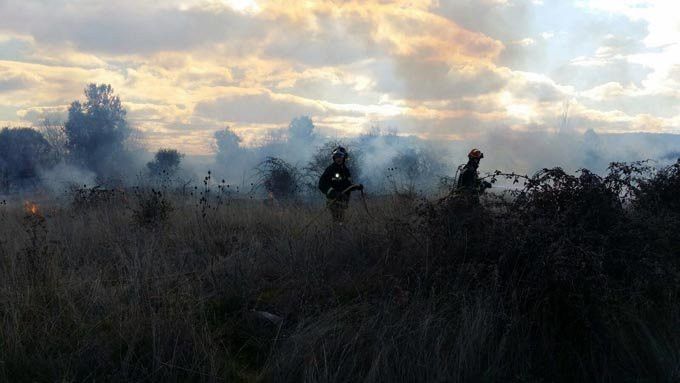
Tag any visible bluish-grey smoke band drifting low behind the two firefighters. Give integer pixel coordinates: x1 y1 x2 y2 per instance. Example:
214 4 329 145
5 112 680 197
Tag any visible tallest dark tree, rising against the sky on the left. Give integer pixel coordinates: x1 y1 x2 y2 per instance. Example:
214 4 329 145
64 84 132 177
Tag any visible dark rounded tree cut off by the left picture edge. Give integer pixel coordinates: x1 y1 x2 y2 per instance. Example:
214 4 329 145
0 128 56 192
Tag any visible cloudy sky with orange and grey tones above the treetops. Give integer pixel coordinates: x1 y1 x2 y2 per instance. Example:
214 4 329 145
0 0 680 154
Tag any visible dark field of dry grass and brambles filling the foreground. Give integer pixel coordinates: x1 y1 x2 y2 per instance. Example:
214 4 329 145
0 164 680 382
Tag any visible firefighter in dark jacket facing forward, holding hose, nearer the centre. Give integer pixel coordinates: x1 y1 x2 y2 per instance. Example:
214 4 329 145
319 146 364 223
